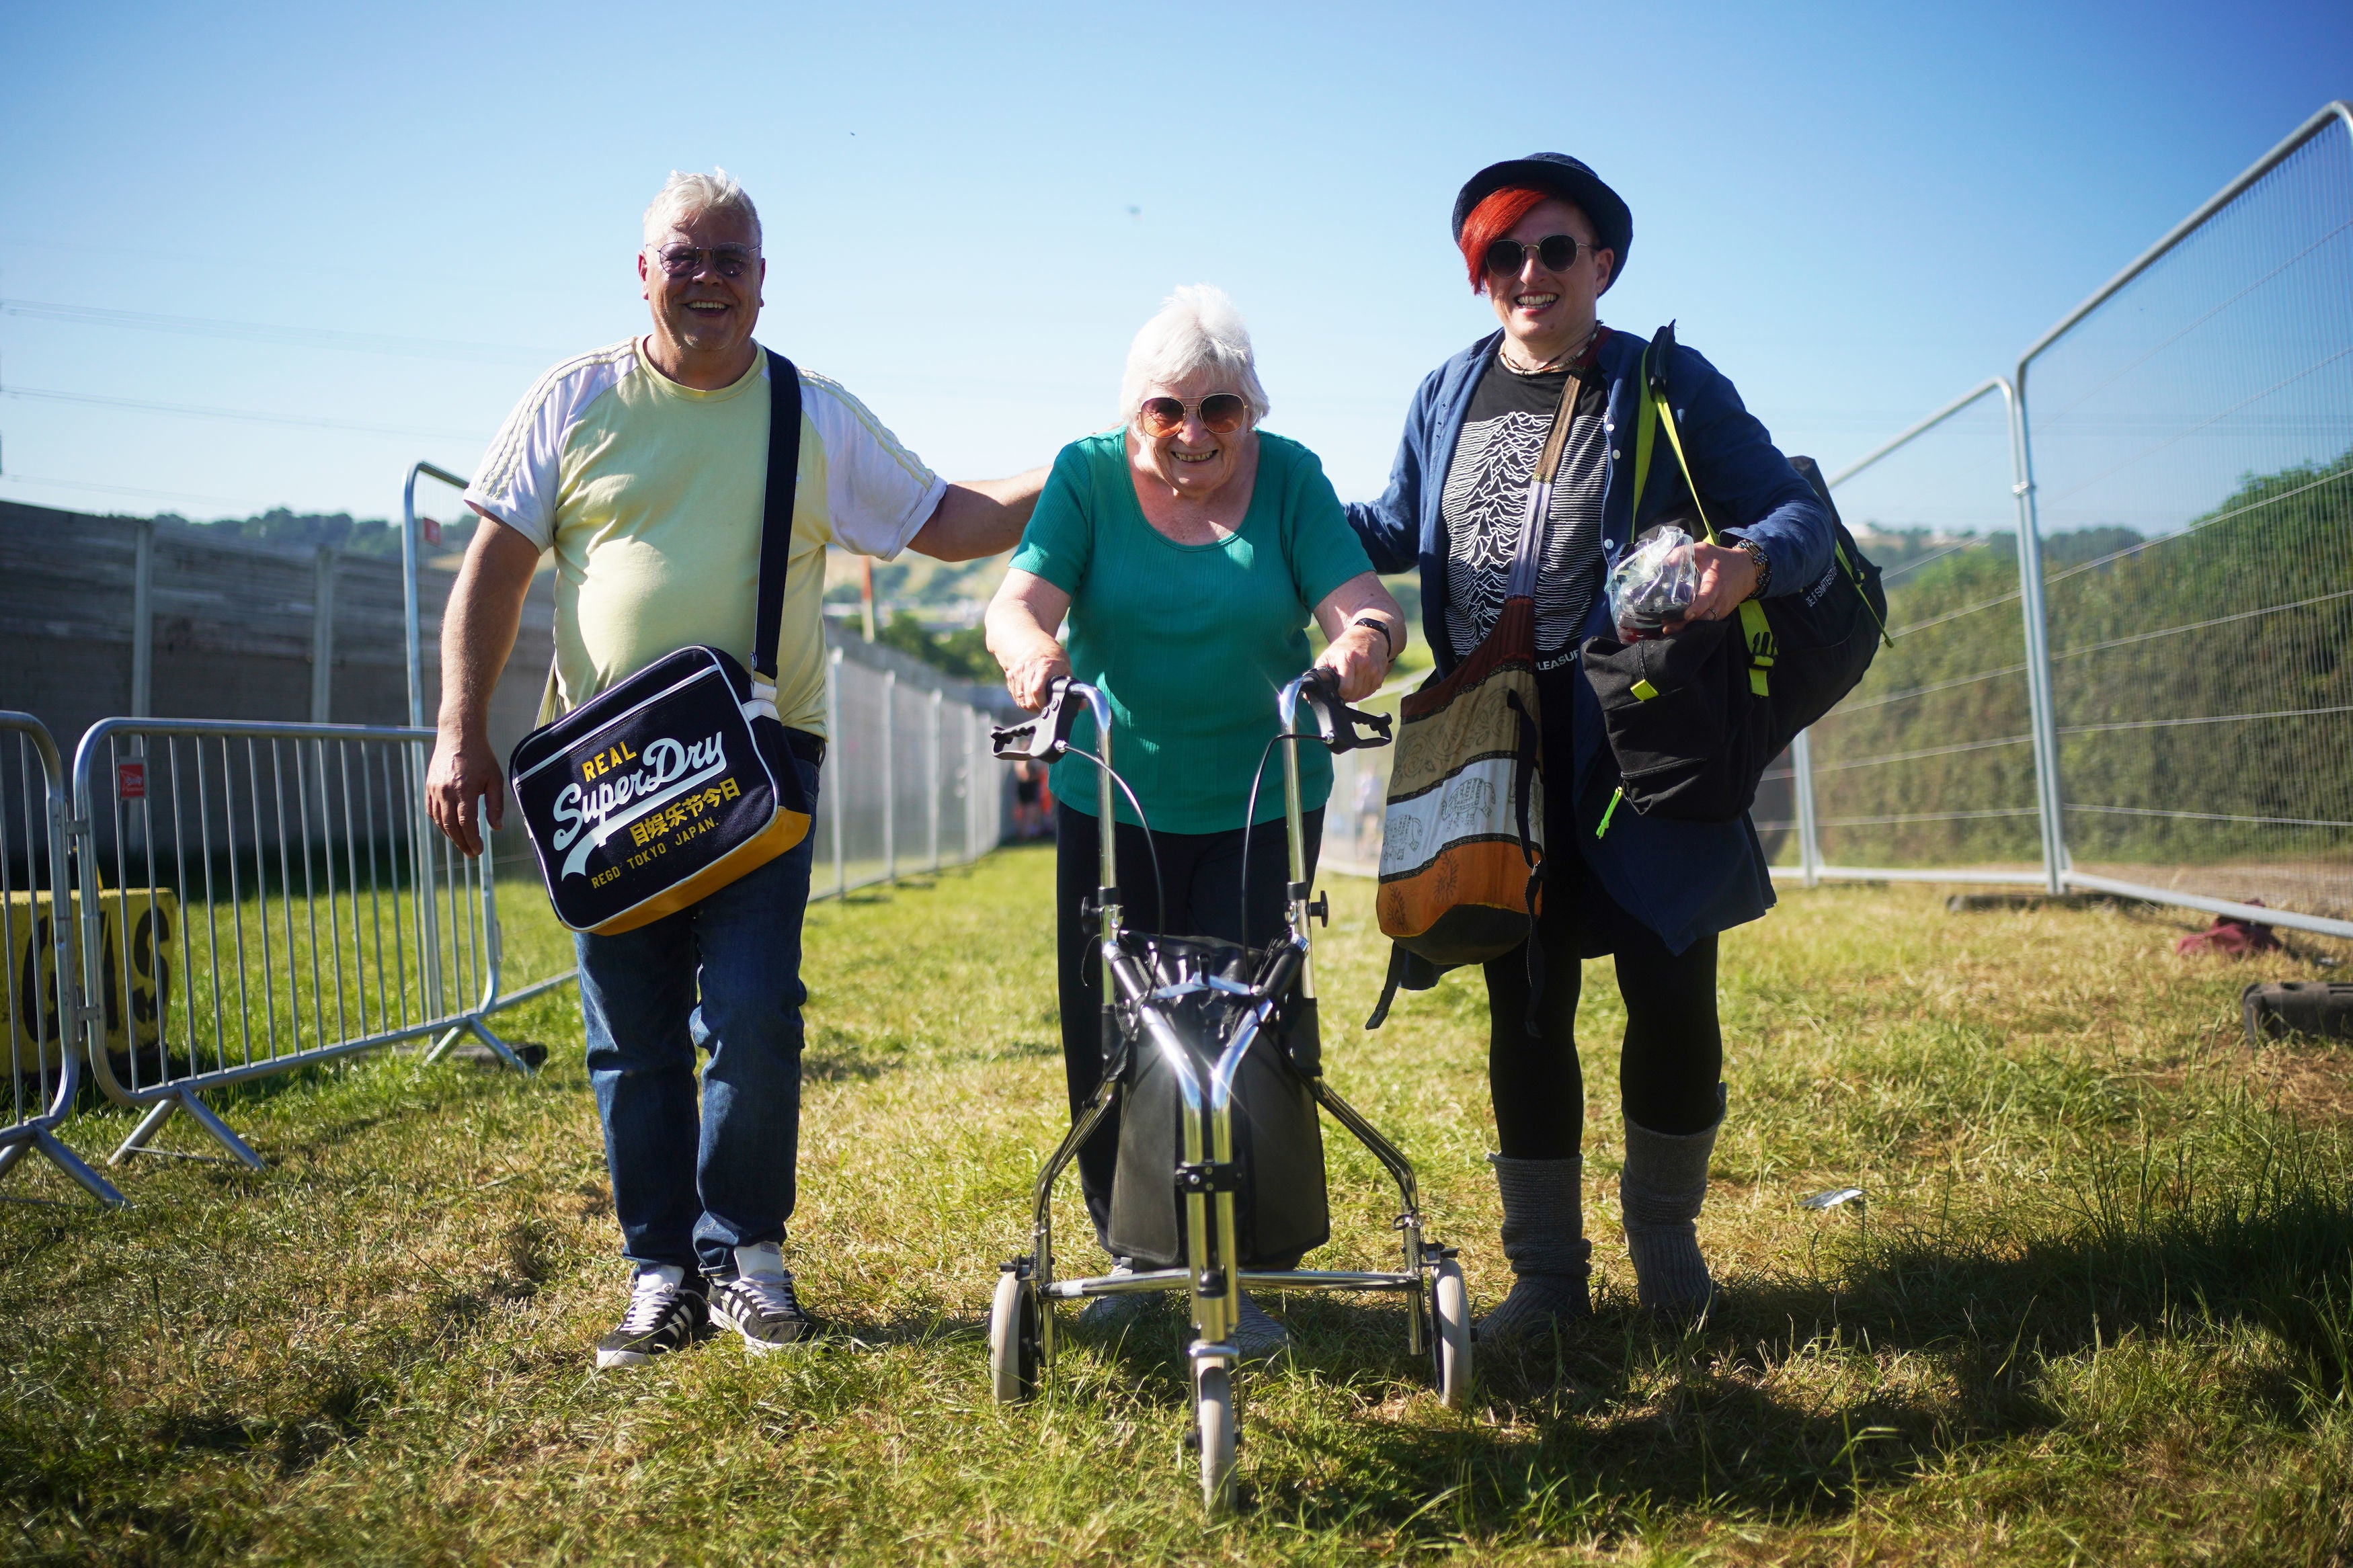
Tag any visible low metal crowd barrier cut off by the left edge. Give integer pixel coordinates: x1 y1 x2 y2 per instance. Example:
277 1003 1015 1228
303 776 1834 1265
0 710 122 1208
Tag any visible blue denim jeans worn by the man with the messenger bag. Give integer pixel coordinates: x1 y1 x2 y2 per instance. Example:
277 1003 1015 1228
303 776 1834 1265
574 759 817 1274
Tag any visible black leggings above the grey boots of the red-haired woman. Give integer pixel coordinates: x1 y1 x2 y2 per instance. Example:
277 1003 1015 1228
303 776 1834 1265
1487 837 1725 1159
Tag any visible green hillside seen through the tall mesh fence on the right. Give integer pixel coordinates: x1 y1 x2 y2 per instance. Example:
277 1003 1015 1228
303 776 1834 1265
1814 454 2353 865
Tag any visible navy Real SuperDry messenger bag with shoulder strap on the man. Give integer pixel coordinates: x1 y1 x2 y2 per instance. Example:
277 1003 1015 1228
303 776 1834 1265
508 353 814 936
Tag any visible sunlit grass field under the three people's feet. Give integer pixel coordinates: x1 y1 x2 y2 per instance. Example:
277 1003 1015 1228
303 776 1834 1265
0 851 2353 1563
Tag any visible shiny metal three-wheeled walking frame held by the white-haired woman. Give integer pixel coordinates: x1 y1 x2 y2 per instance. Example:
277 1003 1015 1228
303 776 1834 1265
988 670 1471 1514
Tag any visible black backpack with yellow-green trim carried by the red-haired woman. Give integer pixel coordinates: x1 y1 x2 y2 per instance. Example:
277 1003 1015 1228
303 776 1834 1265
1581 322 1887 832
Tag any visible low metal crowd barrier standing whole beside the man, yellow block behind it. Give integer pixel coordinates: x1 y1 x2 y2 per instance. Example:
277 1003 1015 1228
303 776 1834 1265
69 719 551 1168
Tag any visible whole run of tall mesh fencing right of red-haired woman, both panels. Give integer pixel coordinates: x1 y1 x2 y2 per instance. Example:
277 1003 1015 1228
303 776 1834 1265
1774 101 2353 938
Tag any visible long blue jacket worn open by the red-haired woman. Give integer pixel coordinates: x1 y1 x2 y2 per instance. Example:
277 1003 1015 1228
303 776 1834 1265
1349 331 1831 952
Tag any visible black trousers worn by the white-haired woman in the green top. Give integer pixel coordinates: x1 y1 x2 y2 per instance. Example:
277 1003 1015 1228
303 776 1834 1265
1054 802 1322 1253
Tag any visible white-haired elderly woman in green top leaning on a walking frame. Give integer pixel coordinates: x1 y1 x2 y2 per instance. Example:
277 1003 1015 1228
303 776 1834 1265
988 287 1405 1354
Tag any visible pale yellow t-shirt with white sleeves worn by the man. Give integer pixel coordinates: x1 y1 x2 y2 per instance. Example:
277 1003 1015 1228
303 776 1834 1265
466 339 949 736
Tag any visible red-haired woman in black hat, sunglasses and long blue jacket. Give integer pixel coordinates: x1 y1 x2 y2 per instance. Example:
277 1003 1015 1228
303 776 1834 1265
1349 153 1831 1340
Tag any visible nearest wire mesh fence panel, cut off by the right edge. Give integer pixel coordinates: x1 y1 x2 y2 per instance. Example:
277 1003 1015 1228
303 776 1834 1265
2019 104 2353 919
